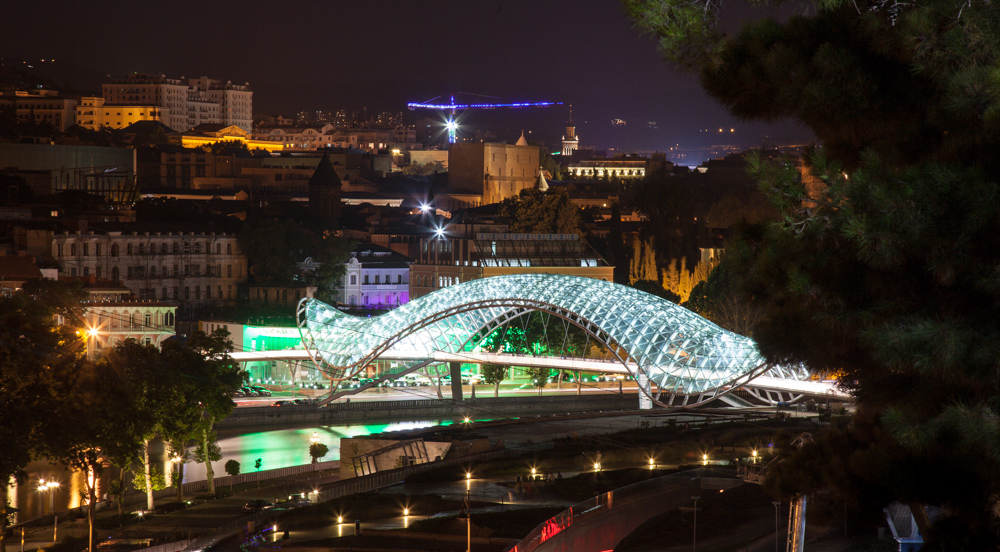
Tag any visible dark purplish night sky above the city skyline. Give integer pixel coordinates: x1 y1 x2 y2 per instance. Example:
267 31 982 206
0 0 810 151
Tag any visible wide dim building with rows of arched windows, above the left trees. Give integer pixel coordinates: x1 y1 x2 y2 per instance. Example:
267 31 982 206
52 232 247 308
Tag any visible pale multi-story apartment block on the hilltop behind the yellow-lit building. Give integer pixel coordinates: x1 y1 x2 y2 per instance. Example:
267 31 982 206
103 73 253 132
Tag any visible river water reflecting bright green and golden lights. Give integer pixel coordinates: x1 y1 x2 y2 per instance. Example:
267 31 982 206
8 420 451 523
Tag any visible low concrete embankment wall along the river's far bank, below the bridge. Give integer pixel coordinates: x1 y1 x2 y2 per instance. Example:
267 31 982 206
216 393 638 429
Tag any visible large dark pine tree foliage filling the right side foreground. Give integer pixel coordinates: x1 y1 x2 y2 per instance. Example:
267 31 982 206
625 0 1000 550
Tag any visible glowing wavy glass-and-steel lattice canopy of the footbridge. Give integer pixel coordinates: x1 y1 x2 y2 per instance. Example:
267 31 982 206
297 274 796 404
